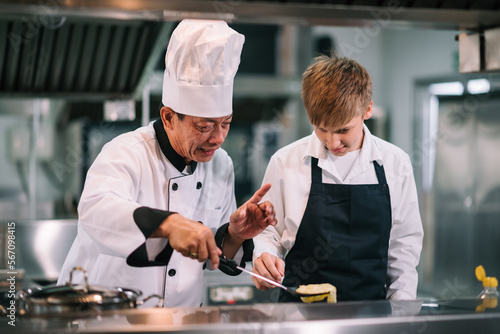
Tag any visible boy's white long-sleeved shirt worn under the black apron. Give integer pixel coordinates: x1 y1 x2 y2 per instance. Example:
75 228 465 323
253 125 423 299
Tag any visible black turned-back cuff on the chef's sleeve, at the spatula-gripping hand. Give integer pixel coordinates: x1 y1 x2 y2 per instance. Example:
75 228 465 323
127 206 175 267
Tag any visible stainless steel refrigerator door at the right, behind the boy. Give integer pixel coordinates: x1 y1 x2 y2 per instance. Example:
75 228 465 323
413 76 500 299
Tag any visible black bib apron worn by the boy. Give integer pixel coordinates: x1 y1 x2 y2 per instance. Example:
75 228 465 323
279 158 391 302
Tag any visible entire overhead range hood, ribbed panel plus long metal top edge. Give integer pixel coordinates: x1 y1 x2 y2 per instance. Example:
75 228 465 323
0 0 500 99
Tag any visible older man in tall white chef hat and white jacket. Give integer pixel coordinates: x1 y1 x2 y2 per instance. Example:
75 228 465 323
58 20 276 306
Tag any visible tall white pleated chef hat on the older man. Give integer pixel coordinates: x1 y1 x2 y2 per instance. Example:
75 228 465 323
162 20 245 118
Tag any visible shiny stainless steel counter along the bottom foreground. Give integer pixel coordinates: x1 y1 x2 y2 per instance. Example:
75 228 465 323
0 299 500 334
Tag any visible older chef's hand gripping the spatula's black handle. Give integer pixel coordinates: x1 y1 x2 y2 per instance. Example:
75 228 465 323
151 213 222 269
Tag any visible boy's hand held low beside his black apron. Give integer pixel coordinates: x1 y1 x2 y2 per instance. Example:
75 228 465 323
252 253 285 291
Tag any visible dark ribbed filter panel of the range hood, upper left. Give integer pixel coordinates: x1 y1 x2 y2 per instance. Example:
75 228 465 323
0 15 170 99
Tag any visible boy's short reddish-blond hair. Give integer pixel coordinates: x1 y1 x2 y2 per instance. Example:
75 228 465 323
302 51 372 128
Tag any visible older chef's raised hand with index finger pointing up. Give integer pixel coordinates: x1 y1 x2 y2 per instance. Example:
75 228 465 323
229 183 277 241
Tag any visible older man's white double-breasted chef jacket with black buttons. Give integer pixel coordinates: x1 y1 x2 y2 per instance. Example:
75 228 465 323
58 121 241 306
